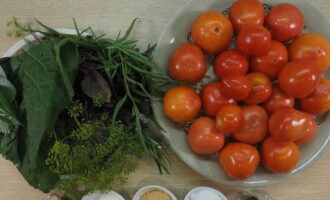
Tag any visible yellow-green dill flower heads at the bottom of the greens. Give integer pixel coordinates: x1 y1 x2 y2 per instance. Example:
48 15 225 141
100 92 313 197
46 102 144 199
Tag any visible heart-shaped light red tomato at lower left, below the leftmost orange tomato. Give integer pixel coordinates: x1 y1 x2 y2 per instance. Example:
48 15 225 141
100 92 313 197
188 117 225 154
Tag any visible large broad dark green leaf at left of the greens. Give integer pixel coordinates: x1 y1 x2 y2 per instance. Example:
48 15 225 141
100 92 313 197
1 39 80 192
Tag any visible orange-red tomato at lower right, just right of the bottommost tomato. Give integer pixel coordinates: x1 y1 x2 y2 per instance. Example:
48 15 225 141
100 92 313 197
261 137 300 173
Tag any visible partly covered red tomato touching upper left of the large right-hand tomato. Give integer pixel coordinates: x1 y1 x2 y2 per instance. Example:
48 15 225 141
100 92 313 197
251 41 288 79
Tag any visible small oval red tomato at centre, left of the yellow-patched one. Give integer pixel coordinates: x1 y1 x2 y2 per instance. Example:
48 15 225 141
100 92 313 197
220 74 252 101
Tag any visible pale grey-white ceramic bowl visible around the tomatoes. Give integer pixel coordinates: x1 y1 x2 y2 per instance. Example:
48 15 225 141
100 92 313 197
153 0 330 187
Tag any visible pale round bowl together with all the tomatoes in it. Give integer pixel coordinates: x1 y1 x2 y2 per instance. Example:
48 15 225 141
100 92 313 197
153 0 330 187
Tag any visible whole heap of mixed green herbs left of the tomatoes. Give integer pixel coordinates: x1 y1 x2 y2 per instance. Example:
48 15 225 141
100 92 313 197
0 19 176 199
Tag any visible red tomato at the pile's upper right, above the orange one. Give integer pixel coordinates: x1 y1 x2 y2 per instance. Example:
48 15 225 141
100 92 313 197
266 3 305 42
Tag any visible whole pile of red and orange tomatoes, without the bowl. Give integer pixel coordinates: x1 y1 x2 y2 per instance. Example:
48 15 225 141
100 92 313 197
163 0 330 179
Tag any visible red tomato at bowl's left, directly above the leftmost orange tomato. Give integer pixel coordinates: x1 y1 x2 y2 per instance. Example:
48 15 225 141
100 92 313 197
168 43 207 83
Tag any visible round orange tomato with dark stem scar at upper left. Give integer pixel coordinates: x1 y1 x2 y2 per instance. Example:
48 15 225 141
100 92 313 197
191 11 234 54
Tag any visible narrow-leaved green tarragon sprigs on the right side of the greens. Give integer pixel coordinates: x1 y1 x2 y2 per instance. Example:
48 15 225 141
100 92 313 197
30 19 177 172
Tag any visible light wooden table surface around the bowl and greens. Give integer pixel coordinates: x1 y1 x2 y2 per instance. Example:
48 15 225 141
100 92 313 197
0 0 330 200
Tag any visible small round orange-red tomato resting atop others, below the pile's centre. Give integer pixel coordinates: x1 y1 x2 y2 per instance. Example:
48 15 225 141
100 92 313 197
215 104 243 133
